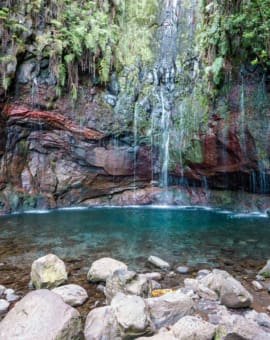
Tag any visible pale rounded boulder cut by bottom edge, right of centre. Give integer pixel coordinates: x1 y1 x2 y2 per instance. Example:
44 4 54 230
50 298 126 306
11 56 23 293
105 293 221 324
171 315 216 340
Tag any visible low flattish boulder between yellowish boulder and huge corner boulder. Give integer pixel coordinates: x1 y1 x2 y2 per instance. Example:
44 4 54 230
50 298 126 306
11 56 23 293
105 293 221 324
52 284 88 306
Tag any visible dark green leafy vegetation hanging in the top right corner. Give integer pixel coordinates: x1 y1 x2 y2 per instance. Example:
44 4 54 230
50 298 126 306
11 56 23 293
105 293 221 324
199 0 270 86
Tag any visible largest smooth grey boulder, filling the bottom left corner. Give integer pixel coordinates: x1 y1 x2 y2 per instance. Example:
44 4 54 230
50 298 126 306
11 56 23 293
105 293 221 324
0 289 82 340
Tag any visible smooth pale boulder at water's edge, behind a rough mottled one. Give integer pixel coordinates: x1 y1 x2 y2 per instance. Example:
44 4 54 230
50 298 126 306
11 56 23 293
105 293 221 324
87 257 127 282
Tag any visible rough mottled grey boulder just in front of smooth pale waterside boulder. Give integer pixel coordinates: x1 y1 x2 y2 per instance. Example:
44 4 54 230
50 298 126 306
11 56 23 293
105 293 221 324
104 269 152 303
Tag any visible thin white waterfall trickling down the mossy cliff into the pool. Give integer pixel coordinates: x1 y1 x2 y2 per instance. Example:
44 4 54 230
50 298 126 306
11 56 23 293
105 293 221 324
130 0 200 192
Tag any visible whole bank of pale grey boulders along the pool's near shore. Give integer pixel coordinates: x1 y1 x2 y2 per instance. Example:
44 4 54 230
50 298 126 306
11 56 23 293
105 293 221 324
0 254 270 340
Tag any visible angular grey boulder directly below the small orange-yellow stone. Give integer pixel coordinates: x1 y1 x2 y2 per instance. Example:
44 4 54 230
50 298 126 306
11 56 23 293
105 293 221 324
145 291 194 329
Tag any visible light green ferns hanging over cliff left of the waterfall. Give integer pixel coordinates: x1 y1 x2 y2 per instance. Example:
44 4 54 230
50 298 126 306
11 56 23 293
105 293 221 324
0 0 158 98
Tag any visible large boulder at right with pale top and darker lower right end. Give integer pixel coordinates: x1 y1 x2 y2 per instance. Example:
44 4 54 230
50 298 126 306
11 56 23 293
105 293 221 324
199 269 253 308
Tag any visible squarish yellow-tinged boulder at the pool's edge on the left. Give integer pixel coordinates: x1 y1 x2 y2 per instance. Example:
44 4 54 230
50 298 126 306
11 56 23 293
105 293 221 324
31 254 67 289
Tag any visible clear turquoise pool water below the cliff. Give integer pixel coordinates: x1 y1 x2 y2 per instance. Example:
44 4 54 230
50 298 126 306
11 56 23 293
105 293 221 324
0 207 270 270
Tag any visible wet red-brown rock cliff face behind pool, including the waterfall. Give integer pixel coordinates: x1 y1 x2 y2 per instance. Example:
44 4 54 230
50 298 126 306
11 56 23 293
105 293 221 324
0 0 270 212
